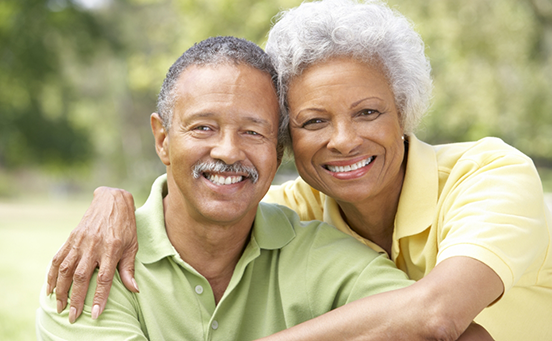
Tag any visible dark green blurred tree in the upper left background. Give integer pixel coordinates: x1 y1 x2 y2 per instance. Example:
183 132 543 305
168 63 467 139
0 0 124 167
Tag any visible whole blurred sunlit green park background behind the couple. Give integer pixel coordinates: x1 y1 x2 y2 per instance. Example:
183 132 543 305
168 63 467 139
0 0 552 340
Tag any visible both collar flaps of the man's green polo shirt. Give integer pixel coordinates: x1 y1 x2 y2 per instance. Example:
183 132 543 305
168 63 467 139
136 174 295 264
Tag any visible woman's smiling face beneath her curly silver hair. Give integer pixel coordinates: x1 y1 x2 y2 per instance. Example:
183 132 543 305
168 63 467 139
288 57 404 203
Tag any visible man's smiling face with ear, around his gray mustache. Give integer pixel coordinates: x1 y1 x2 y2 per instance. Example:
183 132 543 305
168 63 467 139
152 65 279 225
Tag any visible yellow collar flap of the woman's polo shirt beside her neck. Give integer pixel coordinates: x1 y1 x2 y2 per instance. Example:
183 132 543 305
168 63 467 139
393 135 439 240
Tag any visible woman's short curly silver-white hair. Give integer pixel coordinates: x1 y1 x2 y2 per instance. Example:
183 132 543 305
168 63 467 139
266 0 432 142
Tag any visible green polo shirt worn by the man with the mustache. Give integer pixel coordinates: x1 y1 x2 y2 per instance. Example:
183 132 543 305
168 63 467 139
36 176 412 341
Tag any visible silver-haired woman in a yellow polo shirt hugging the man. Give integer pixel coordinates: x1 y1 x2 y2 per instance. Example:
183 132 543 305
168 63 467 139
48 0 552 340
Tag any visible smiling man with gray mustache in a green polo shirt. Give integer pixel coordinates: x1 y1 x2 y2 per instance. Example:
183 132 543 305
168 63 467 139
37 37 411 340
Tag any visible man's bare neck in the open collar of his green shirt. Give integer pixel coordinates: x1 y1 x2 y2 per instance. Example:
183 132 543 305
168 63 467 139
163 196 255 304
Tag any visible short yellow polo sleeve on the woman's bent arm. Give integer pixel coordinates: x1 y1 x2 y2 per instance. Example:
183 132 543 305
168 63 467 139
437 141 550 292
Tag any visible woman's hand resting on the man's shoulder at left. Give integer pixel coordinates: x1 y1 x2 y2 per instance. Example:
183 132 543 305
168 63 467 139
47 187 138 323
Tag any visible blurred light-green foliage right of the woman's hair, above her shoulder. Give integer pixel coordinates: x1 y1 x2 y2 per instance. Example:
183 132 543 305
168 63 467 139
390 0 552 166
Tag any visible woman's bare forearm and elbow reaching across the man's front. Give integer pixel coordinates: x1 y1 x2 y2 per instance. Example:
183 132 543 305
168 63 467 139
256 257 503 341
